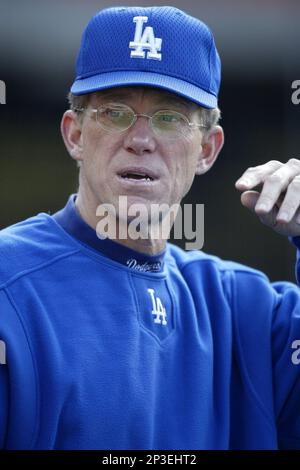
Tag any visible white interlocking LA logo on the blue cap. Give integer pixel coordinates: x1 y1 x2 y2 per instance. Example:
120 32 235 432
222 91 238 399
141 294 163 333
129 16 162 60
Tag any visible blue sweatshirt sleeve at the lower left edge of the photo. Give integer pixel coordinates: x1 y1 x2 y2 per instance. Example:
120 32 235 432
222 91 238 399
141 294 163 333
0 288 37 450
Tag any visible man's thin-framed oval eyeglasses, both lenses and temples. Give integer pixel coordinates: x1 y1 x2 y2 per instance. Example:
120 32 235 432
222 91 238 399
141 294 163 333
75 103 207 140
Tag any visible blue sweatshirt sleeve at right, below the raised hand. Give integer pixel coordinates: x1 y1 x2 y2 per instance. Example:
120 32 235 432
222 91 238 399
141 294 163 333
231 240 300 449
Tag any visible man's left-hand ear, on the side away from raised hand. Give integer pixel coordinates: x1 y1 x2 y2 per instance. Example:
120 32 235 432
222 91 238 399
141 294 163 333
60 109 82 161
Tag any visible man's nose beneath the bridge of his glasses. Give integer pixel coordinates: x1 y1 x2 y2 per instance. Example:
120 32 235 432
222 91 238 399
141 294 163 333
124 115 156 155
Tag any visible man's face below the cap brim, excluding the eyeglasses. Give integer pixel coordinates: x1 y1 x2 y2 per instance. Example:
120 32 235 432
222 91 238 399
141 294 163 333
70 87 207 215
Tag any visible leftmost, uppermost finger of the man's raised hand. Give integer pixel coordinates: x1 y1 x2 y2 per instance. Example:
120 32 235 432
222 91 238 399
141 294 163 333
235 160 284 191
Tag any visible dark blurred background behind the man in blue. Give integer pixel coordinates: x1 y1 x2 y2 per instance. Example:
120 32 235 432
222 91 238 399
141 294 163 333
0 0 300 281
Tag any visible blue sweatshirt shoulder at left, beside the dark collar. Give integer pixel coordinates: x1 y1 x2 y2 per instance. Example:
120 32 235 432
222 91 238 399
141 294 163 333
0 213 77 287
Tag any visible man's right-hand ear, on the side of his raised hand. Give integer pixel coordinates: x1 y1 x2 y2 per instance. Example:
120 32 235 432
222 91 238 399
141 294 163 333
196 126 224 175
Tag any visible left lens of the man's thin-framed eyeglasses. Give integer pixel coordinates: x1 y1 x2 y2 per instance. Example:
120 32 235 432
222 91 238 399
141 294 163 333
97 104 134 132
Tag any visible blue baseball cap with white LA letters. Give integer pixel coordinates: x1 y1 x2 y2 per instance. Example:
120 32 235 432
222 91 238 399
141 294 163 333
71 6 221 108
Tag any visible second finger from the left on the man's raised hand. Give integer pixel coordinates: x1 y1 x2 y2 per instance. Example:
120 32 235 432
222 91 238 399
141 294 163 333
256 162 300 215
